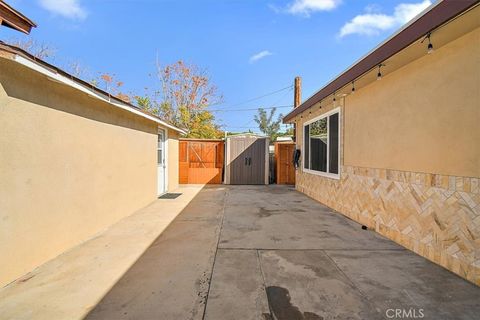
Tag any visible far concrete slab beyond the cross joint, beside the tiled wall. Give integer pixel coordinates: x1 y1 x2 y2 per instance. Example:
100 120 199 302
220 186 403 250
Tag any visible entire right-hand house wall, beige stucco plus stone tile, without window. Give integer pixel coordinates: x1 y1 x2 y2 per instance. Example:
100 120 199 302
296 28 480 284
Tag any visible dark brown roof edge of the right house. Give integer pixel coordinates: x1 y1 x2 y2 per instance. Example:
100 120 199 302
283 0 480 123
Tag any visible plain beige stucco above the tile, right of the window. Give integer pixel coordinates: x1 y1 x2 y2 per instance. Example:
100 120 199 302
345 29 480 177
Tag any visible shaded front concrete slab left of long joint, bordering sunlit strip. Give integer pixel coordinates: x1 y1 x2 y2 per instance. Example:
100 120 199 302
86 220 219 320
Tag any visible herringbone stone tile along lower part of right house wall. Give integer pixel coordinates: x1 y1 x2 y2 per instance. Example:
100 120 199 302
296 166 480 285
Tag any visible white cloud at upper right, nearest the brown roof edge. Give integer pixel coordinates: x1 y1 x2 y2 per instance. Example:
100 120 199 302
339 0 432 37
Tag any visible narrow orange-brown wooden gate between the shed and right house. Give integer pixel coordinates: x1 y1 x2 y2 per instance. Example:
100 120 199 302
275 142 295 184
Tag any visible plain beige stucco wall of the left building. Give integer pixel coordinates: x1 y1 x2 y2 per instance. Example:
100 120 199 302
0 58 161 286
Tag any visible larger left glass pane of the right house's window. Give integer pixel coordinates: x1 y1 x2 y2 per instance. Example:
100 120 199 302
310 118 328 172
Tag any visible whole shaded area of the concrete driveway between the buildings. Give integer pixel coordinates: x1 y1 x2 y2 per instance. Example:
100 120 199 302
87 186 480 320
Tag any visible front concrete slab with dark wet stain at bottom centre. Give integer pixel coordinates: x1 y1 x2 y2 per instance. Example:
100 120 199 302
260 250 382 320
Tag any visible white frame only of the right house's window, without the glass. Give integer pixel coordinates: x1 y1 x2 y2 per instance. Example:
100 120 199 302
302 107 342 180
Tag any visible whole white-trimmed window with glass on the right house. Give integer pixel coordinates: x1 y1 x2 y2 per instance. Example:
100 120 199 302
303 109 340 178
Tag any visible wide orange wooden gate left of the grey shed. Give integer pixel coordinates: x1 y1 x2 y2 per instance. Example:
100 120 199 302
179 139 224 184
